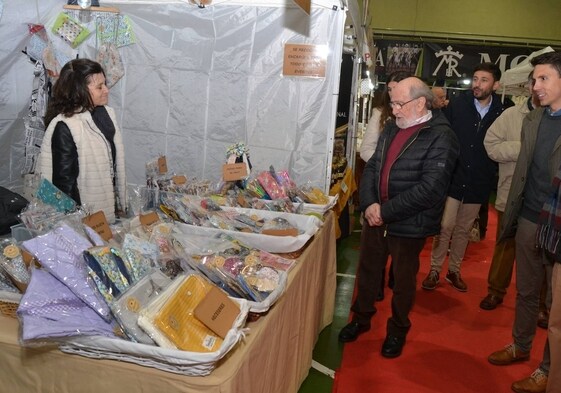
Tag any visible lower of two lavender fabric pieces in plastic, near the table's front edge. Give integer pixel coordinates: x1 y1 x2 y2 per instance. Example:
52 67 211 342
17 269 115 343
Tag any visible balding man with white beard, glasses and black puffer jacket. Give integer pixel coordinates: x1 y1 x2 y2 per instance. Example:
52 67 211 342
339 78 460 358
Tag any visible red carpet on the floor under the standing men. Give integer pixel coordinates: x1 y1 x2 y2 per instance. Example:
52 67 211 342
333 209 547 393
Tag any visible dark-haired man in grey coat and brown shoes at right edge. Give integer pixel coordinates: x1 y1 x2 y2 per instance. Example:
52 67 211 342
488 52 561 393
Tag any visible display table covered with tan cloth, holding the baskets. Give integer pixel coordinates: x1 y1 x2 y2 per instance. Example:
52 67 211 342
0 212 336 393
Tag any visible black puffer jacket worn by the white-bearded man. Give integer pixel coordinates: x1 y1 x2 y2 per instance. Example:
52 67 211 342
360 111 460 238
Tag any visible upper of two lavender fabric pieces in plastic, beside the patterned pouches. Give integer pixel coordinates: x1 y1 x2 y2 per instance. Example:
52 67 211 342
22 224 111 320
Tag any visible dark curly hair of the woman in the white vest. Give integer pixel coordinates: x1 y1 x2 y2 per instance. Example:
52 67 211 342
45 59 105 127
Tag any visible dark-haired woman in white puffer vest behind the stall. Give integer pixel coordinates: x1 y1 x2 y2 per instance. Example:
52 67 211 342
39 59 126 222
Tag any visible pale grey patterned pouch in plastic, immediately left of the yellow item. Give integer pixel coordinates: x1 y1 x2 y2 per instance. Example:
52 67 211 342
111 269 171 345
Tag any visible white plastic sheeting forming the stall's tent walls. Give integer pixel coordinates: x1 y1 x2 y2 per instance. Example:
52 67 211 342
0 0 346 190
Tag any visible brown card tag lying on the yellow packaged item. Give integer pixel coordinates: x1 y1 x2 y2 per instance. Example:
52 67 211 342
194 286 240 338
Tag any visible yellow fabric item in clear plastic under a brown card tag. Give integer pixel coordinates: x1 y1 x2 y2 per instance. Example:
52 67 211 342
154 275 223 352
